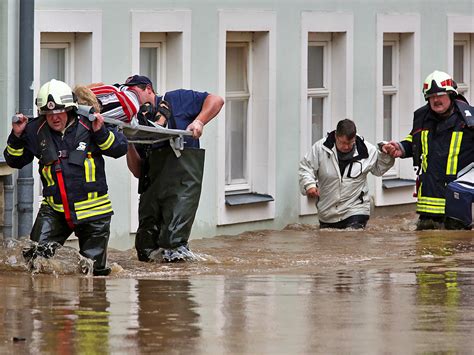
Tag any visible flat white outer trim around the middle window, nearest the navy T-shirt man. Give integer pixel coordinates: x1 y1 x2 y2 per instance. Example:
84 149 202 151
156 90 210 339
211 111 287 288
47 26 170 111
216 9 277 225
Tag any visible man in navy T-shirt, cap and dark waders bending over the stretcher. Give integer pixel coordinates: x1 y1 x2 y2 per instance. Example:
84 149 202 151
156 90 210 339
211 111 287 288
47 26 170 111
124 75 224 262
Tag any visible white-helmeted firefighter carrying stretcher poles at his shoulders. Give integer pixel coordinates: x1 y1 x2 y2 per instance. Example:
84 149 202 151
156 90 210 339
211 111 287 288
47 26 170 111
4 79 128 275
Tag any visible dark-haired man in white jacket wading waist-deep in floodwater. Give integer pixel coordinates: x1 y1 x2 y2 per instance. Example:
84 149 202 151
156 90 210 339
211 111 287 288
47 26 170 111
299 119 395 229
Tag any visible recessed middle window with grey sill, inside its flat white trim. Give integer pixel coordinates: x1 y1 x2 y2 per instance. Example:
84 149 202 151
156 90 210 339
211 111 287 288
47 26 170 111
225 31 273 206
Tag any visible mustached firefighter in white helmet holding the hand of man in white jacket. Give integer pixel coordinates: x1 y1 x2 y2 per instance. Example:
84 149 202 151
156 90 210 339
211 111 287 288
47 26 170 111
382 70 474 230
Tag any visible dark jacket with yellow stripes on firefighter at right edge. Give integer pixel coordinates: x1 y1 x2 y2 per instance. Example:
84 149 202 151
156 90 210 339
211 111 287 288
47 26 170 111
401 100 474 216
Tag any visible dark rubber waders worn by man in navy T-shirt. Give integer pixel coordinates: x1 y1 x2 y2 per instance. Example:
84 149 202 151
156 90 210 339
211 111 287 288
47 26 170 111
135 147 205 261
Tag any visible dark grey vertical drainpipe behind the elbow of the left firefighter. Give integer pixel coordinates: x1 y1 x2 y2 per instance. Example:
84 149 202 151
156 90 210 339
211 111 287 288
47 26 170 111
17 0 35 237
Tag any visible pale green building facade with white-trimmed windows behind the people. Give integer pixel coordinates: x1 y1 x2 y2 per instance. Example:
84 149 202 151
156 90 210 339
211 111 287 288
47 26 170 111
0 0 474 248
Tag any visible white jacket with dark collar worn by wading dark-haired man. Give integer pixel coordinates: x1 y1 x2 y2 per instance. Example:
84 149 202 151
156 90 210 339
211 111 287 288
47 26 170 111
299 131 395 223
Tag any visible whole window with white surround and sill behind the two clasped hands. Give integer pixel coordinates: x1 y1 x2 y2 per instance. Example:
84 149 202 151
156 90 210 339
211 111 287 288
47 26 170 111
369 14 423 206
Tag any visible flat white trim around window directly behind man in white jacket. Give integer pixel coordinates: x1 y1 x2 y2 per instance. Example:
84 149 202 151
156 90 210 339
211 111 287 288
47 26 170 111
299 12 354 215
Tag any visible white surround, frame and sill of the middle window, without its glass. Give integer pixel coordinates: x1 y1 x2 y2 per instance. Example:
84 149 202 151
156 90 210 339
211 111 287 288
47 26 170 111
215 9 276 226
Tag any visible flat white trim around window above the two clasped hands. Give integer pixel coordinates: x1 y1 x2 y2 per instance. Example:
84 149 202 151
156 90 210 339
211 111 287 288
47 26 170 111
374 14 424 206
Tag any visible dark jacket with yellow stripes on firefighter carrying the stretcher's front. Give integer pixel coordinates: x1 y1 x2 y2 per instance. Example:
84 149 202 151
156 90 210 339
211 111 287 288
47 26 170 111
4 116 127 224
